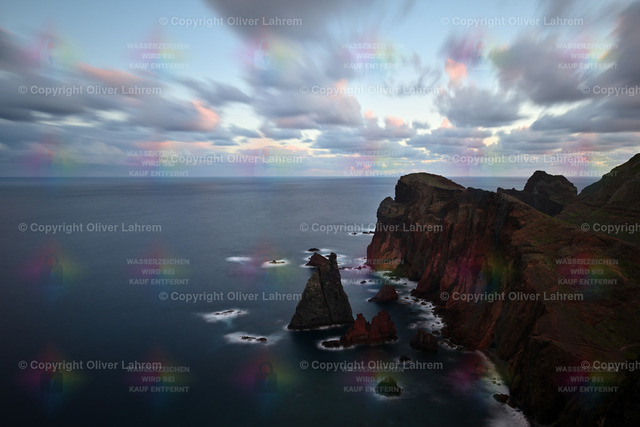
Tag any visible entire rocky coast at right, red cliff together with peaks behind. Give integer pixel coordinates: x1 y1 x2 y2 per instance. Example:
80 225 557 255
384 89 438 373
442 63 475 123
367 154 640 426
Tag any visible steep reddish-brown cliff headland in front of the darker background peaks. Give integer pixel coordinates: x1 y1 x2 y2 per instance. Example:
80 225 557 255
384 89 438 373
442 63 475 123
367 173 640 425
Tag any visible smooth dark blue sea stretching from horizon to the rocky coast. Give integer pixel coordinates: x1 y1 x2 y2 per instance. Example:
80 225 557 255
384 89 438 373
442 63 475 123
0 177 594 426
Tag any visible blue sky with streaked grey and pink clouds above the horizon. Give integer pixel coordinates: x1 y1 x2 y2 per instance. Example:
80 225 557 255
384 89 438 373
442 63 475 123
0 0 640 177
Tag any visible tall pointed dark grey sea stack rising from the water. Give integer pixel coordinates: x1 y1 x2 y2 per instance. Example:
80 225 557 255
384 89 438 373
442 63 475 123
288 252 353 329
